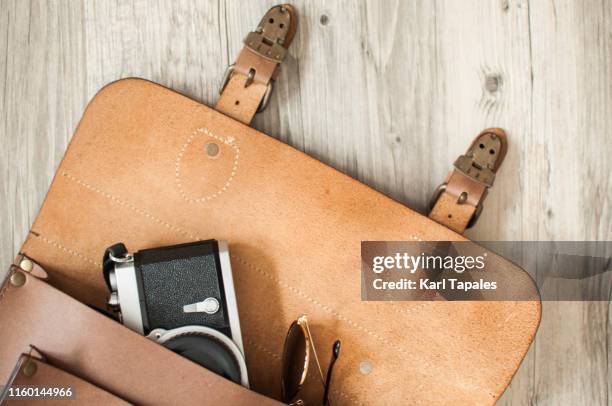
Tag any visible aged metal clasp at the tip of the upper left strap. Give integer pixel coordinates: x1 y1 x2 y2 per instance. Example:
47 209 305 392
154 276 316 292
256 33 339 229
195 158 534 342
244 5 291 63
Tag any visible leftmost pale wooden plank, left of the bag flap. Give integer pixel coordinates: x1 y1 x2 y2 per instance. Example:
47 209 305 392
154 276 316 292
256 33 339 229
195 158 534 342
0 0 87 276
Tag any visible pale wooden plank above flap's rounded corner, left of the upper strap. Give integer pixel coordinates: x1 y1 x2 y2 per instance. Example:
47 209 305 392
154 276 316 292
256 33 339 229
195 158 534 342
84 0 231 104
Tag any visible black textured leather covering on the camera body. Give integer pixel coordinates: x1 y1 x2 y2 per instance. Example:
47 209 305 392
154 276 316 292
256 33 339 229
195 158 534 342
134 240 232 337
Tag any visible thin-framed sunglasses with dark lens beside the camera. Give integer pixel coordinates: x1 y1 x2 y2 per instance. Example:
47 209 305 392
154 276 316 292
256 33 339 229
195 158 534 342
281 315 340 406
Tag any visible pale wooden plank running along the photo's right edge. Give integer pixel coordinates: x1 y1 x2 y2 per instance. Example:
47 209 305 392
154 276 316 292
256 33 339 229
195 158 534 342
522 1 612 405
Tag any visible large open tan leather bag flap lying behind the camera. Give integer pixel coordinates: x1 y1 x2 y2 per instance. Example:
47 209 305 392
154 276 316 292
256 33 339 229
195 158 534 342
15 79 540 404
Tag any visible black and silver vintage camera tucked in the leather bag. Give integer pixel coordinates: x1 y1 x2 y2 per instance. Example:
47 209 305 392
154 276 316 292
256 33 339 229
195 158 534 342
103 240 249 388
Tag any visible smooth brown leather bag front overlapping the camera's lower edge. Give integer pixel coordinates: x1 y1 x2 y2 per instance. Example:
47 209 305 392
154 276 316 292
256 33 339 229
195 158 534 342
0 275 277 405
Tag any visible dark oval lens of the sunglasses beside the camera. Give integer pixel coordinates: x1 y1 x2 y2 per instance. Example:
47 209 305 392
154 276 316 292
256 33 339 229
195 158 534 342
281 322 307 402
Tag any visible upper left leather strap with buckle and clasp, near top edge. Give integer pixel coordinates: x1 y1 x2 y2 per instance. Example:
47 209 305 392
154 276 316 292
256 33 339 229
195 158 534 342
215 4 297 124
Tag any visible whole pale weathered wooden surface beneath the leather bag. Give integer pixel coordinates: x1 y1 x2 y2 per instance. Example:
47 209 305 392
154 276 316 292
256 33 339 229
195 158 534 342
0 0 612 405
